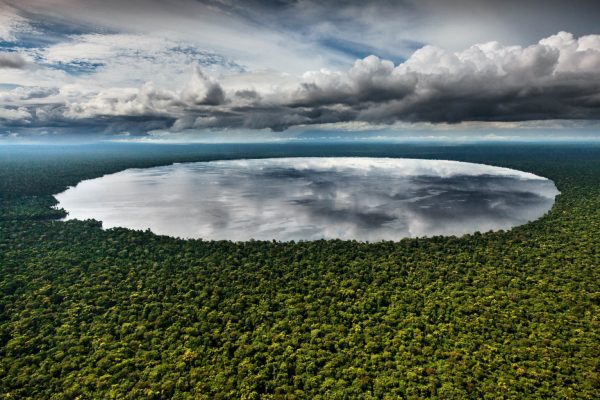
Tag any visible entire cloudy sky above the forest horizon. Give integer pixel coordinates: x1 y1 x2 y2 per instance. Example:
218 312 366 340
0 0 600 142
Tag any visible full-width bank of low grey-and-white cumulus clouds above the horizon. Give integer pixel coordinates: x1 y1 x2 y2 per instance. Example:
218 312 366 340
3 32 600 136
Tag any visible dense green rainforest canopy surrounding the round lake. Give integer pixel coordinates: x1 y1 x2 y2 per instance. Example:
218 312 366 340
0 145 600 399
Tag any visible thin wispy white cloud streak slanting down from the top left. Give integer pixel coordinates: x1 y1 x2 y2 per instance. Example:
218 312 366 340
0 0 350 73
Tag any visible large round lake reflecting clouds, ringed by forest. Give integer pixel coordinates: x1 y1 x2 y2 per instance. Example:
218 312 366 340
55 157 559 241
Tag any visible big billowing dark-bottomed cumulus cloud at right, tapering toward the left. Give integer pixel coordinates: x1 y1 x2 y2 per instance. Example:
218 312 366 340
154 32 600 130
